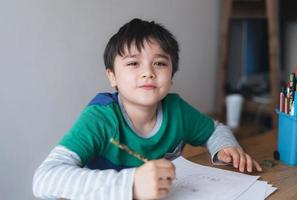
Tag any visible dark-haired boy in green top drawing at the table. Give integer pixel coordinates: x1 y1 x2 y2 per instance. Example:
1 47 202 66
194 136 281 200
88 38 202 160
33 19 262 199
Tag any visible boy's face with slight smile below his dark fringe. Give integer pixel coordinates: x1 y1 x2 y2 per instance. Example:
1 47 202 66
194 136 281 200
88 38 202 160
107 40 172 106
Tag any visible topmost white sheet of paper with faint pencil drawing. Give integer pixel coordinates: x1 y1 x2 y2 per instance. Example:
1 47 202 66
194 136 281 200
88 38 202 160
167 157 259 200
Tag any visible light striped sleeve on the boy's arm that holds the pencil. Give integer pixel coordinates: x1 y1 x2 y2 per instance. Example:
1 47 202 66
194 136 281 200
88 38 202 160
33 146 135 200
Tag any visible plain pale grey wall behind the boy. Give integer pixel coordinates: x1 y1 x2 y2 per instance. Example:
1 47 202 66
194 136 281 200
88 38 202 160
0 0 220 200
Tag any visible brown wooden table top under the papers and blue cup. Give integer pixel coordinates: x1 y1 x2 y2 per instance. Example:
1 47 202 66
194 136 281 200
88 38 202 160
188 131 297 200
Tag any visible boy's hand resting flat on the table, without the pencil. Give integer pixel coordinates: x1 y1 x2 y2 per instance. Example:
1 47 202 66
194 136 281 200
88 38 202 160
218 147 262 172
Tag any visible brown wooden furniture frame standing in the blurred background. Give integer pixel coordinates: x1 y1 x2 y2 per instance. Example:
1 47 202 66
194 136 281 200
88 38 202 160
218 0 280 128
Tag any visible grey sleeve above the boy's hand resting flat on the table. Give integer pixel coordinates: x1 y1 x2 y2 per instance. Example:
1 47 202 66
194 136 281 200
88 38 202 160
205 121 240 164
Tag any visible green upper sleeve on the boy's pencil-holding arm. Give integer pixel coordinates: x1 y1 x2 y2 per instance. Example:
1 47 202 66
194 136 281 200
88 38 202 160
59 106 115 166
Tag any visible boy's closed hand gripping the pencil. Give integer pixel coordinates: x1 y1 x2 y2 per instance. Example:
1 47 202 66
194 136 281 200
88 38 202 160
133 159 175 199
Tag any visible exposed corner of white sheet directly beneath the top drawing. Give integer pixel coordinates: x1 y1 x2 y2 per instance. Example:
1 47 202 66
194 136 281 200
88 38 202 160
236 181 268 200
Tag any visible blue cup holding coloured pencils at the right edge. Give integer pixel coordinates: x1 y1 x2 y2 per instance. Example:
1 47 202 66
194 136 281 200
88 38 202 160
276 110 297 166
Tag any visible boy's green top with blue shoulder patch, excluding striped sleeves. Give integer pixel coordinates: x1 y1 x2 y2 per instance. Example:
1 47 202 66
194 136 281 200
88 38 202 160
59 93 214 170
